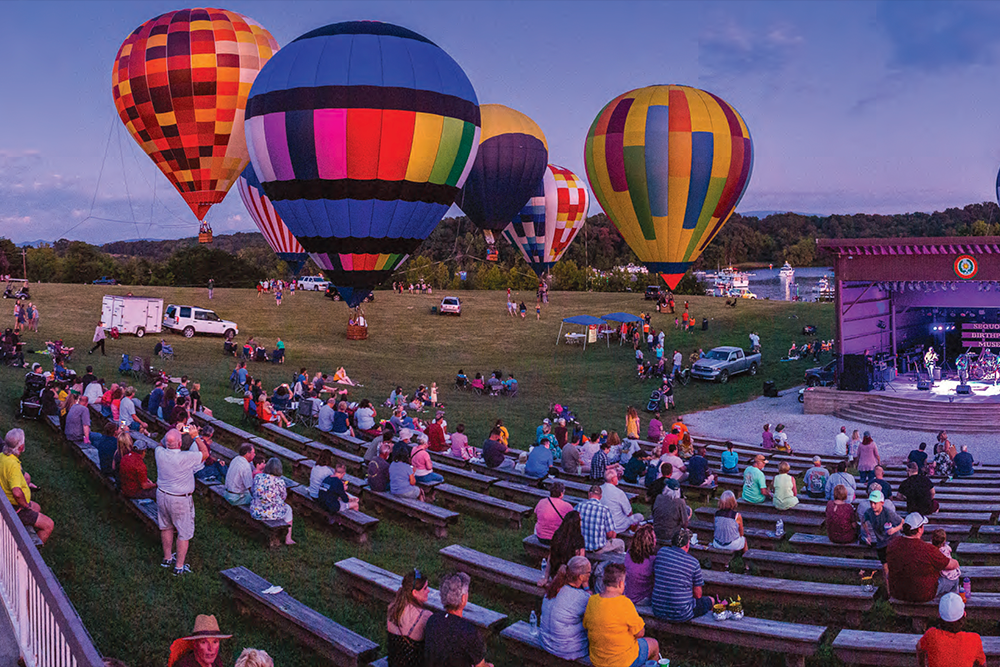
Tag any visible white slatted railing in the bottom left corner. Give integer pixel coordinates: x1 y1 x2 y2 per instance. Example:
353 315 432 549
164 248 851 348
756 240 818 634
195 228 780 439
0 493 103 667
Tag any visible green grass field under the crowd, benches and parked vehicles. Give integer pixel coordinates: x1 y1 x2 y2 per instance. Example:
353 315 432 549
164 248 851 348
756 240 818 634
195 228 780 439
0 285 836 667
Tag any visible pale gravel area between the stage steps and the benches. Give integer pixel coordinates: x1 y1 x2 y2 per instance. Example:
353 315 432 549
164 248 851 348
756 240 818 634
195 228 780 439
684 387 1000 463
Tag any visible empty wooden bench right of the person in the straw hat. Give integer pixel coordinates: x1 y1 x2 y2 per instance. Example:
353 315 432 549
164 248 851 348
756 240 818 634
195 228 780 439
220 567 379 667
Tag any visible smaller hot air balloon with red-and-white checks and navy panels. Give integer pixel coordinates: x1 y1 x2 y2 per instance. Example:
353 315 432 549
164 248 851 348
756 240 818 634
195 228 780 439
504 164 590 277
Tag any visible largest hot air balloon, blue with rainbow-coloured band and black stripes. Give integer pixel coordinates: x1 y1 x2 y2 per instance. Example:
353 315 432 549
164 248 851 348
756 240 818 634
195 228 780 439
246 21 479 324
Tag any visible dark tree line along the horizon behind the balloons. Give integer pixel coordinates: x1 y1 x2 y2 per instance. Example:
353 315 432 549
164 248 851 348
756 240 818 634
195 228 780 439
7 202 1000 294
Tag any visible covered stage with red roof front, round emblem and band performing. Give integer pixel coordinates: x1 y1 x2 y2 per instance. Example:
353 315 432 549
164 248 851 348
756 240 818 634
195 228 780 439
818 236 1000 402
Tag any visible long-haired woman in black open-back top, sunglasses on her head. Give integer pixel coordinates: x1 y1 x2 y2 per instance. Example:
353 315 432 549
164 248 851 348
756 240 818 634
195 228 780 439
386 568 431 667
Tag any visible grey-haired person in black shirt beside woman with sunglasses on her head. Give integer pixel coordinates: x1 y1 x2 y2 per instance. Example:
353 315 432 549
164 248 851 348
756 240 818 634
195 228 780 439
424 572 493 667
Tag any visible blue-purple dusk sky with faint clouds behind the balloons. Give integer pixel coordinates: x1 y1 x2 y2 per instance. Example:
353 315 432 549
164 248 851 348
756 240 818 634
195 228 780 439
0 0 1000 243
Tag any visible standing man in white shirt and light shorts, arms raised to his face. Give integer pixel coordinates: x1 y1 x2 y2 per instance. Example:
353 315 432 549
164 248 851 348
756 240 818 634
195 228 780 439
155 426 208 577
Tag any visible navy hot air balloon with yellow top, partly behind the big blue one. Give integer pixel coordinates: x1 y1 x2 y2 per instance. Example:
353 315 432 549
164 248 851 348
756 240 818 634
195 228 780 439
455 104 549 249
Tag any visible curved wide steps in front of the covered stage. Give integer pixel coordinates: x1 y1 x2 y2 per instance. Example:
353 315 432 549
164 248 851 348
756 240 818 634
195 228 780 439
833 393 1000 433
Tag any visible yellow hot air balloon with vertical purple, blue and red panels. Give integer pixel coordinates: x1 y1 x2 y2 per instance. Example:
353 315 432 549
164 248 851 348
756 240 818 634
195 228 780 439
584 86 753 289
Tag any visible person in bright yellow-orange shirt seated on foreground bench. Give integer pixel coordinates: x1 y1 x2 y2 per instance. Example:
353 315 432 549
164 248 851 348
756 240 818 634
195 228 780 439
583 563 660 667
